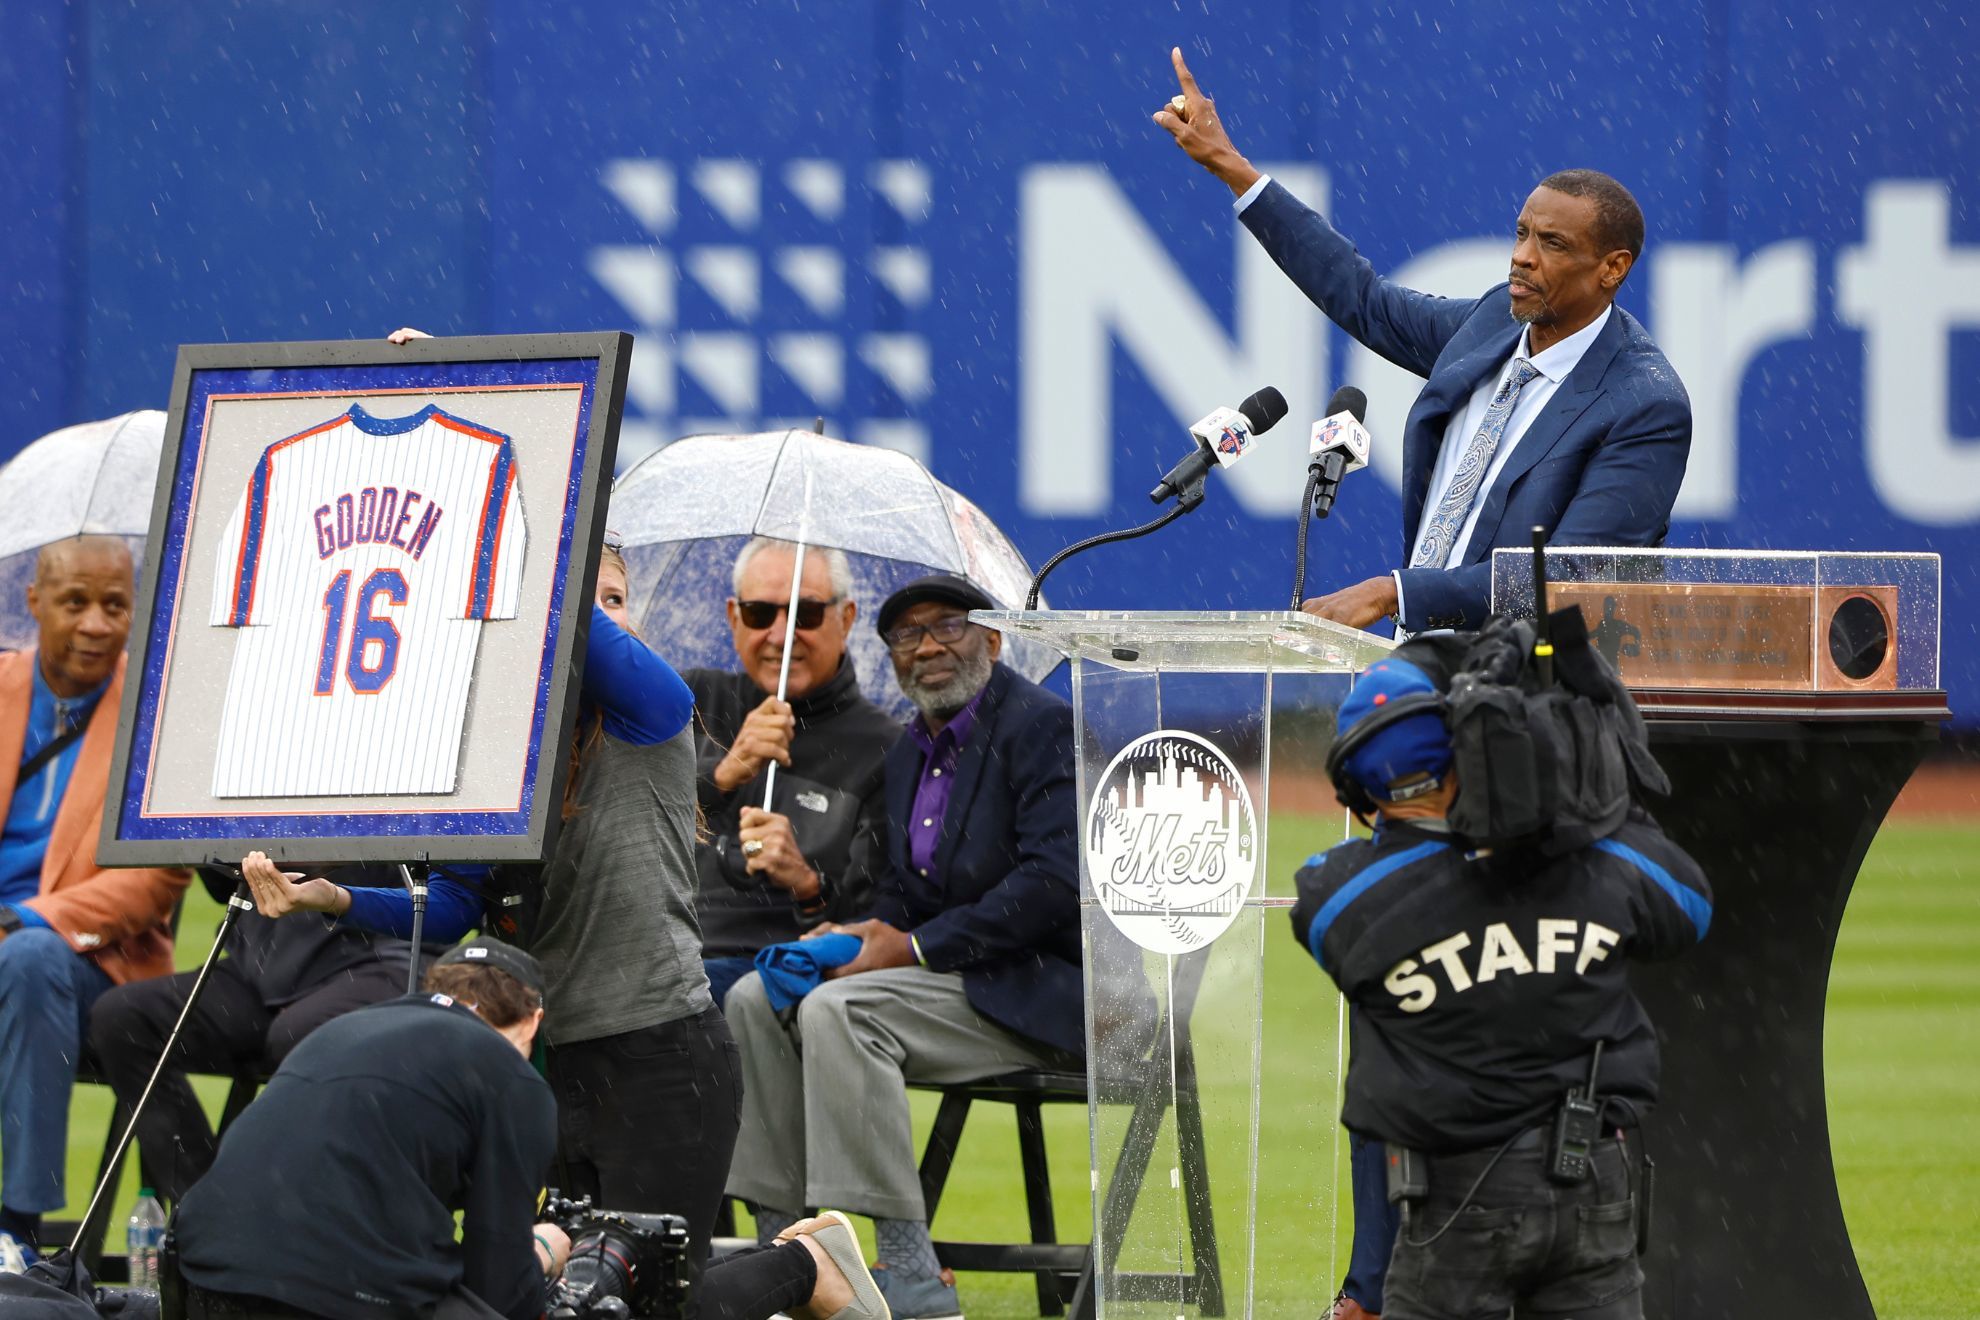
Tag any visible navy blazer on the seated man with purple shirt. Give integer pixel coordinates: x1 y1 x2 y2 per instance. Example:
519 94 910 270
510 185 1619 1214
871 665 1087 1055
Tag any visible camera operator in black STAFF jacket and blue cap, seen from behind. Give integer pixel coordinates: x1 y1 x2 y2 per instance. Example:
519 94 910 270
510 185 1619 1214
1293 657 1711 1320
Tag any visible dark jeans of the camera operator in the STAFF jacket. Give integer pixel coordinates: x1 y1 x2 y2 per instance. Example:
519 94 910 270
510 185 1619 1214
1382 1128 1643 1320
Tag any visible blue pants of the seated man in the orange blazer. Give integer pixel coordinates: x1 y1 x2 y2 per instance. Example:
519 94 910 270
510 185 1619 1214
0 926 111 1215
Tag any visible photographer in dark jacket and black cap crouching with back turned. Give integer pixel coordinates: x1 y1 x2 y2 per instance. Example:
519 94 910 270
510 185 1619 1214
174 940 570 1320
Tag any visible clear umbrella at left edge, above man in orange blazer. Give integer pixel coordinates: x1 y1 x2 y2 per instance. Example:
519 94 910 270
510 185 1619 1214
0 408 164 649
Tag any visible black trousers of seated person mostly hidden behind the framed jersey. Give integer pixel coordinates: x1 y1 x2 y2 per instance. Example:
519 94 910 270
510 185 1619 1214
89 962 406 1203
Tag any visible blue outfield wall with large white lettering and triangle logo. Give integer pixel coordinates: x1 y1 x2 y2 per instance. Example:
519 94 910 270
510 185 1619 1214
0 0 1980 724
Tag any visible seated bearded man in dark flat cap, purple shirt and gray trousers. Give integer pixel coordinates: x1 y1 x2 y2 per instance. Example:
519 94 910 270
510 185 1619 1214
727 574 1085 1320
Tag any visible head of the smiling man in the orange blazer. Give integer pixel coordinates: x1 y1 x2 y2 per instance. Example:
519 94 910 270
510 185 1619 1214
28 536 137 697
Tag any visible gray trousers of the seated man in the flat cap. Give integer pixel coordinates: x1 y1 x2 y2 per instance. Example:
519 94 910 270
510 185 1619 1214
727 968 1051 1219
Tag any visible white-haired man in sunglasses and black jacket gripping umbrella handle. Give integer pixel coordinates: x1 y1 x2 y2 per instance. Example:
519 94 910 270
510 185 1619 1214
683 536 901 1005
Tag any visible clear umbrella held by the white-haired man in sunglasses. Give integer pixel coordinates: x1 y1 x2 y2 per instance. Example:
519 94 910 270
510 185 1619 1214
606 431 1059 718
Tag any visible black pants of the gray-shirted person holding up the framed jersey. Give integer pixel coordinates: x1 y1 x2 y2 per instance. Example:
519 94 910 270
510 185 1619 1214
548 1007 743 1265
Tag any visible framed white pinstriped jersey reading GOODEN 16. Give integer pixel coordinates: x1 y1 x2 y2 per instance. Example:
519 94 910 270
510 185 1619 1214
99 334 632 865
